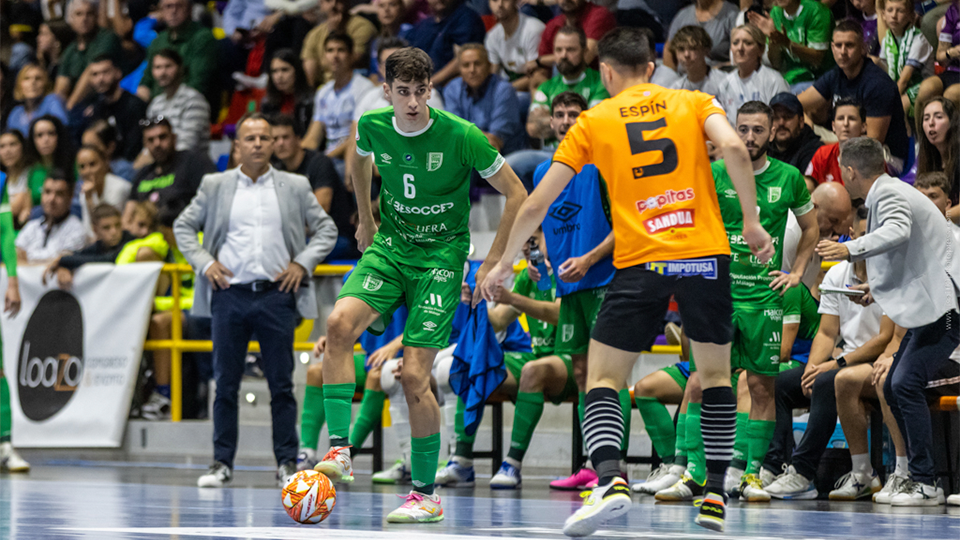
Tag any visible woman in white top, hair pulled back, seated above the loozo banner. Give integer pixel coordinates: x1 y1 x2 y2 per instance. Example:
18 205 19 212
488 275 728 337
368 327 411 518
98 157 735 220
77 146 131 237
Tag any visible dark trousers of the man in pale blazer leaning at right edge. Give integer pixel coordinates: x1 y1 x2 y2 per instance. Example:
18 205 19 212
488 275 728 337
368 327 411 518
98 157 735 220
883 311 960 485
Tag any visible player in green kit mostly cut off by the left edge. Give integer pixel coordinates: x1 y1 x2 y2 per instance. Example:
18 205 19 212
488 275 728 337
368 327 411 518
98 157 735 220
0 177 24 472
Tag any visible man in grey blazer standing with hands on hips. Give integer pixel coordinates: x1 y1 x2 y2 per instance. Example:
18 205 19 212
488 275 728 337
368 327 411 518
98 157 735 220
173 114 337 487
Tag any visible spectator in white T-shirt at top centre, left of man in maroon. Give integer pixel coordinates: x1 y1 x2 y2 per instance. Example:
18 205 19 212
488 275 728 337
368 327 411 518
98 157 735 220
483 0 553 92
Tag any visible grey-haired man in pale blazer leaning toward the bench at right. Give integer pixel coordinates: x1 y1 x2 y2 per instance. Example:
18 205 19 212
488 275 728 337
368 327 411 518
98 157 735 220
817 137 960 506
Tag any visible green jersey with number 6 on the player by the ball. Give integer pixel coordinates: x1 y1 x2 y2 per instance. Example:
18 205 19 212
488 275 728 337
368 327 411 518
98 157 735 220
357 107 505 269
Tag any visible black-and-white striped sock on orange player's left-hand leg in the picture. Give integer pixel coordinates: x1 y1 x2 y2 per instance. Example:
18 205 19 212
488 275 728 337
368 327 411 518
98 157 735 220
583 388 623 486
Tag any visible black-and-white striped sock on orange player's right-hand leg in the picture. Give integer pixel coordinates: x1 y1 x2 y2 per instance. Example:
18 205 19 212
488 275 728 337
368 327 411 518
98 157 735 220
700 386 737 493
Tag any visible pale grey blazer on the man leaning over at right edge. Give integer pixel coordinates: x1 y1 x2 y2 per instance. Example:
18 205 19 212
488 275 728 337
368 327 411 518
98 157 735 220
846 174 960 328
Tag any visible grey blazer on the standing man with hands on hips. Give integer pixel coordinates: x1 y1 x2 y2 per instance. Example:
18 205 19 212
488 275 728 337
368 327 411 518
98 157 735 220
173 169 337 319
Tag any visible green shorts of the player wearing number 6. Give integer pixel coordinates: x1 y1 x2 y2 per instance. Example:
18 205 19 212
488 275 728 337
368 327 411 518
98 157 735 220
337 244 463 349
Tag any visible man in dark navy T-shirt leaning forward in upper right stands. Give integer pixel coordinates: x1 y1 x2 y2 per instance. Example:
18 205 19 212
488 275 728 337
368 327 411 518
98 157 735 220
799 20 909 171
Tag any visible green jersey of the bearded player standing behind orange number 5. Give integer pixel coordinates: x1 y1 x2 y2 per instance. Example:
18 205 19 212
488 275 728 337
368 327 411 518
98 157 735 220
712 157 813 306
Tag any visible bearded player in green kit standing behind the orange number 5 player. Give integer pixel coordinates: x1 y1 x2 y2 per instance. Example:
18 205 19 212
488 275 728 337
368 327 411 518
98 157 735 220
657 101 820 502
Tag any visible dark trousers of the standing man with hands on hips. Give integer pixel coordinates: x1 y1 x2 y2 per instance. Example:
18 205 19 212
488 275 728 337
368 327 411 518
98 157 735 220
210 286 298 468
